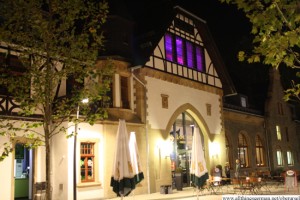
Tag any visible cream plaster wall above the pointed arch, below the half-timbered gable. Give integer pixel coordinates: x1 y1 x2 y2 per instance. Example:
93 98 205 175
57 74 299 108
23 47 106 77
146 77 222 134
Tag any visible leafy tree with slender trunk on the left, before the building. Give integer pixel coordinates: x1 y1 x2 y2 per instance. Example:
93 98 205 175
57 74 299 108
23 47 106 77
0 0 113 200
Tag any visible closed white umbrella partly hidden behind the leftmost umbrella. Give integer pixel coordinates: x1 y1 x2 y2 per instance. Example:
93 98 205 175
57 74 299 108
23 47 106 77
129 132 144 184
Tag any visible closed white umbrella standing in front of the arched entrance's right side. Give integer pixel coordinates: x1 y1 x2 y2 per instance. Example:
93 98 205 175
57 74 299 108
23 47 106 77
190 127 208 188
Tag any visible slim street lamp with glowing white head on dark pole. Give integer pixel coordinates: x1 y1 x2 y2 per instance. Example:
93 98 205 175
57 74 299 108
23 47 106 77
73 98 89 200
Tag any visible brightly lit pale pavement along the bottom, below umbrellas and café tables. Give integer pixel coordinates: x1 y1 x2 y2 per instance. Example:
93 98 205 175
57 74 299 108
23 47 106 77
106 185 300 200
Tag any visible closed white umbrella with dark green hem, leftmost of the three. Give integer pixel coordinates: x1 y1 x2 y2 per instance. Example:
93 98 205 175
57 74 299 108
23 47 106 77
110 119 135 199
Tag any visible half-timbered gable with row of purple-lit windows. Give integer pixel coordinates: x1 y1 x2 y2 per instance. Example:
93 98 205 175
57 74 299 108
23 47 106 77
146 9 222 88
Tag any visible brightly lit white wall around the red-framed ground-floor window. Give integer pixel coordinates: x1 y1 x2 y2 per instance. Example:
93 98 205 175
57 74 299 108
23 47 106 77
61 123 105 200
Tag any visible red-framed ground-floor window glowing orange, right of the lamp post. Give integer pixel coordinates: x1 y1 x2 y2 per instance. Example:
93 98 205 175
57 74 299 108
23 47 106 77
80 142 95 182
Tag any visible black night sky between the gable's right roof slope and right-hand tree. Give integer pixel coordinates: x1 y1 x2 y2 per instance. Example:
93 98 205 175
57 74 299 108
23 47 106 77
174 0 268 109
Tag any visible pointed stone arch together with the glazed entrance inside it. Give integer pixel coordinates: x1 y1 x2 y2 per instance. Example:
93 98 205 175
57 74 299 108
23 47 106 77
164 104 210 187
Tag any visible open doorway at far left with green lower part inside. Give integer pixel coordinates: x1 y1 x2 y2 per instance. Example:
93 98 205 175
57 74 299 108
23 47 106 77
14 143 33 199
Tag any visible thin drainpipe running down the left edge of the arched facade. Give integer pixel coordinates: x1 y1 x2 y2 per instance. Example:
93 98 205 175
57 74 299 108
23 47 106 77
131 65 150 194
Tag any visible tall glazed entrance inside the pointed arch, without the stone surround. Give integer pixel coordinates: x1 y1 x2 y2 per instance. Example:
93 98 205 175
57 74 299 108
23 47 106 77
170 111 204 187
